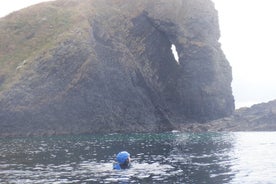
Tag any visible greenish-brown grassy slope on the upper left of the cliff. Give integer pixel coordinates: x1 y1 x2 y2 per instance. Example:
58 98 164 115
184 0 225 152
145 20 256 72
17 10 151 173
0 1 93 91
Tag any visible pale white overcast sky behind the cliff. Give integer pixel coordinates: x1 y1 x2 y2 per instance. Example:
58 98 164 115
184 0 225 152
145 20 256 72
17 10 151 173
0 0 276 107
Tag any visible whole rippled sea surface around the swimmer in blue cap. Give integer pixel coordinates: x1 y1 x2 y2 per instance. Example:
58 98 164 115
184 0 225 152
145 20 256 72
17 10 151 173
0 132 276 184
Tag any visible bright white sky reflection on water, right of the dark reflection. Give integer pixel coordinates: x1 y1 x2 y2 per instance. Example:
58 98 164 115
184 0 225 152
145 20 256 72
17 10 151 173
231 132 276 184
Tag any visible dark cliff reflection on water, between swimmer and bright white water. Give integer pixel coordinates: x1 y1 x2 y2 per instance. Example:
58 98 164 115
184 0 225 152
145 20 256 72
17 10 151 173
170 133 234 183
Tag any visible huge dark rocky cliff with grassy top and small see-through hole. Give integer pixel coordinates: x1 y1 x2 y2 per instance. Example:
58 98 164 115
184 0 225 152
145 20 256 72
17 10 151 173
0 0 234 135
